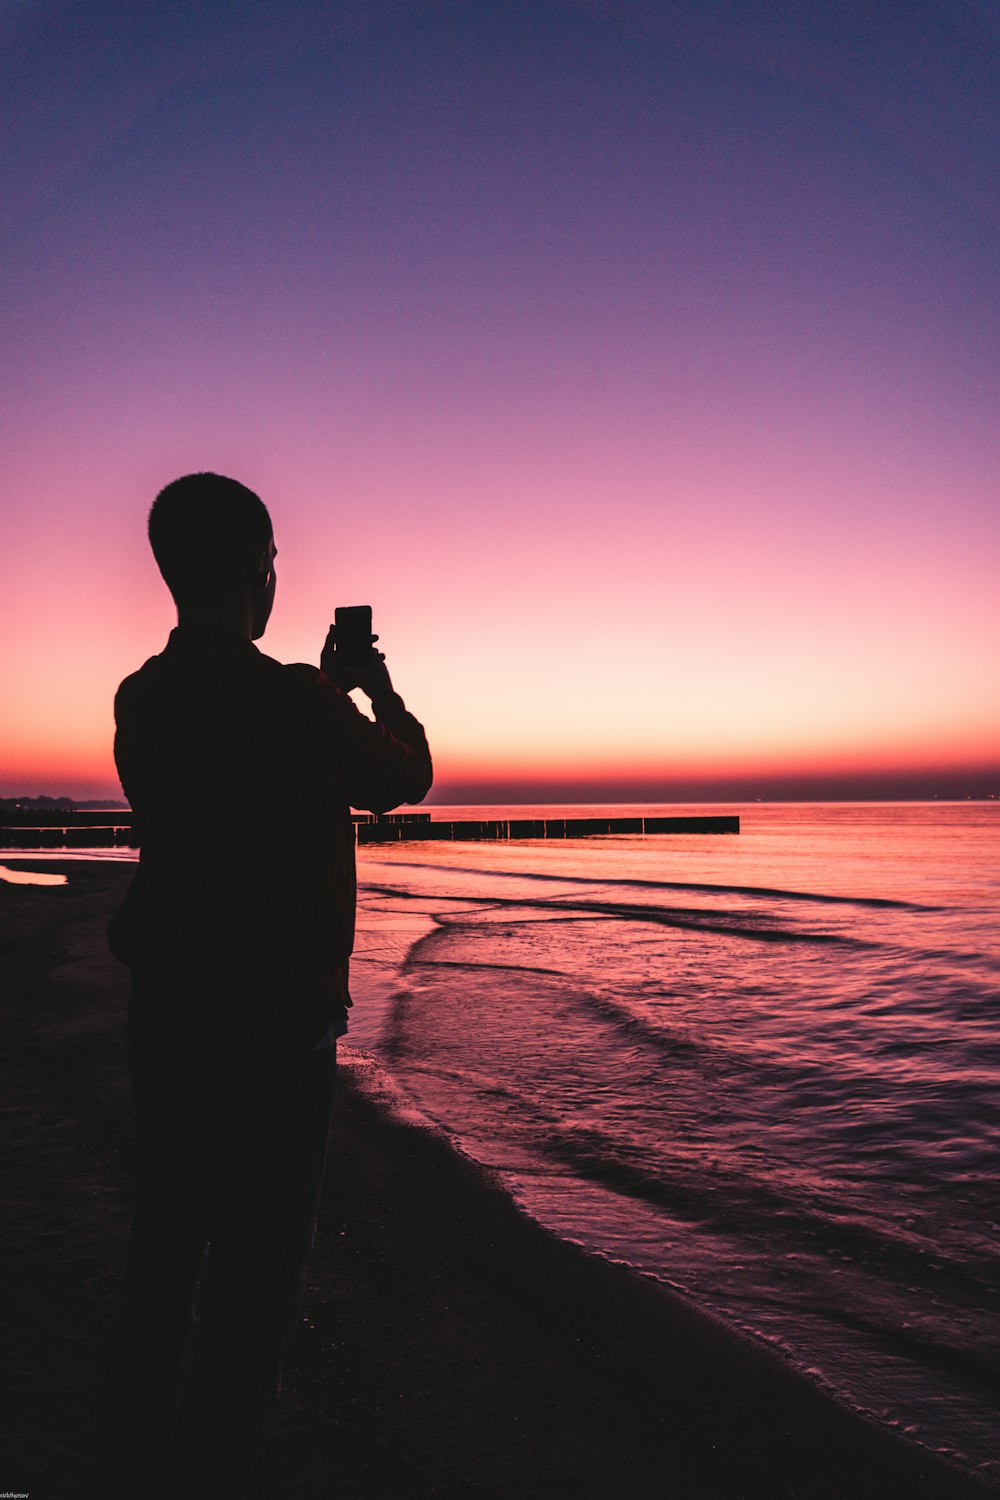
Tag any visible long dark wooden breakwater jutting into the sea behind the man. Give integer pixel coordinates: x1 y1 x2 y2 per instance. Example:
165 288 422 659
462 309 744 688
0 810 739 851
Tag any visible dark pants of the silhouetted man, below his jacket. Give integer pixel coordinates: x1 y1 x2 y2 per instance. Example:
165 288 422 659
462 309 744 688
103 1010 336 1500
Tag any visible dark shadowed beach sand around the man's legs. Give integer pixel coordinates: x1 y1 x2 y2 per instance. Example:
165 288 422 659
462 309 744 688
0 860 996 1500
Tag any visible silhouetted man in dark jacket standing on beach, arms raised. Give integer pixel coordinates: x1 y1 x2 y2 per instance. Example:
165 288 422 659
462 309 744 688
105 474 432 1500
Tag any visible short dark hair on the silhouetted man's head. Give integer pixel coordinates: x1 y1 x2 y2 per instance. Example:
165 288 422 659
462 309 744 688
150 474 273 603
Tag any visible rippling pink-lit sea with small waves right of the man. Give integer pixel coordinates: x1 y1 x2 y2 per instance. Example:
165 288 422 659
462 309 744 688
341 801 1000 1490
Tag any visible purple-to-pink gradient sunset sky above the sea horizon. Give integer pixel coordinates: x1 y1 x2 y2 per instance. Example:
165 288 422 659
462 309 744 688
0 0 1000 801
